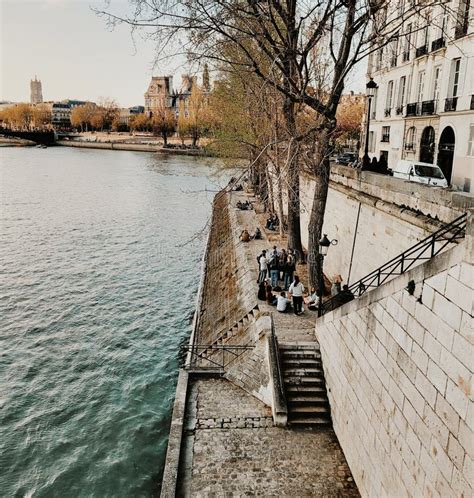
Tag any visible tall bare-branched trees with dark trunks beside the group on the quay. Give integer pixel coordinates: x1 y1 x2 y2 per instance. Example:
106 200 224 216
96 0 441 284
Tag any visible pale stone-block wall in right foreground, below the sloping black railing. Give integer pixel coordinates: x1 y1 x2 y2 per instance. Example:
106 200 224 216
316 210 474 498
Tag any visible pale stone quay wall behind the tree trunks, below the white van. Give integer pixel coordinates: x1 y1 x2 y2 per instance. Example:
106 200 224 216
268 164 474 283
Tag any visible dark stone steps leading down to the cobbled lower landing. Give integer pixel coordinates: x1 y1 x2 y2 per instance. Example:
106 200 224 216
279 342 331 427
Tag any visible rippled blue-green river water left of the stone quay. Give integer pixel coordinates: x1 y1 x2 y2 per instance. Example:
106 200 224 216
0 147 228 498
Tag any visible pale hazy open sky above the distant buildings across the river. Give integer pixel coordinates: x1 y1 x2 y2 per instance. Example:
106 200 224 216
0 0 365 107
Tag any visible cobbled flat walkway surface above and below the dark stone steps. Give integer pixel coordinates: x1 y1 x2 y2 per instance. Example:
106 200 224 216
178 189 359 497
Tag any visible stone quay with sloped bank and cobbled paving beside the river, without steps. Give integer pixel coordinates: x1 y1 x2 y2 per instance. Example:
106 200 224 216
162 192 359 497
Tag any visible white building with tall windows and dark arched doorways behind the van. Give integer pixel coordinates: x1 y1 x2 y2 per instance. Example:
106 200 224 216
361 0 474 192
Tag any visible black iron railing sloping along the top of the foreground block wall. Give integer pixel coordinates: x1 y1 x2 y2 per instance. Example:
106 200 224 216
322 214 467 315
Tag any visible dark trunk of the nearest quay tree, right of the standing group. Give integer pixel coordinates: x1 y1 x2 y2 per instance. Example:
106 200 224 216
308 124 333 292
